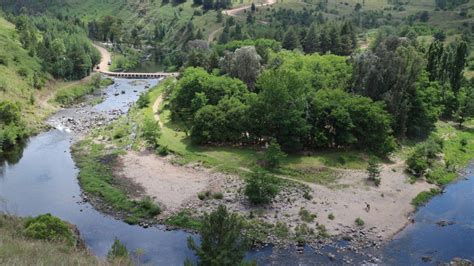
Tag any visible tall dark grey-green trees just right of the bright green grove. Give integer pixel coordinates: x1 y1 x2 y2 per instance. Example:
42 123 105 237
352 37 441 138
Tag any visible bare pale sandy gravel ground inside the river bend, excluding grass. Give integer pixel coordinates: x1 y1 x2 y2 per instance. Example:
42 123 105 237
116 152 432 240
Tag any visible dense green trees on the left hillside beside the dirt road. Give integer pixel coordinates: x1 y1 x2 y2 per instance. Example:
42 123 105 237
15 15 100 80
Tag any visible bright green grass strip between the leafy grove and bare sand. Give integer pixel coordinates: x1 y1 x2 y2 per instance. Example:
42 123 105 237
142 80 366 180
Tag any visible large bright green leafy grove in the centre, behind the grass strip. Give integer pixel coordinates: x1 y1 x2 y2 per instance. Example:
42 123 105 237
170 48 394 154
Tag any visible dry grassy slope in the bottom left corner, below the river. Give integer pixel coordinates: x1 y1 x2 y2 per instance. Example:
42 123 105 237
0 214 130 265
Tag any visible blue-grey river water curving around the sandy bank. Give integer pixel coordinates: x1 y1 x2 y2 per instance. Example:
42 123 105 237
0 79 474 265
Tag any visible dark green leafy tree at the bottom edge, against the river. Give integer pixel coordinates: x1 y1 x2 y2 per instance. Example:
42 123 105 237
188 205 249 266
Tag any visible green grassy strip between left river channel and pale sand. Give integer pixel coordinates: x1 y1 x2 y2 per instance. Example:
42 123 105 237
73 140 160 224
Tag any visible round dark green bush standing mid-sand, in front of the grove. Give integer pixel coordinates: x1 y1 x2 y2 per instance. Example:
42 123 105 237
245 171 278 204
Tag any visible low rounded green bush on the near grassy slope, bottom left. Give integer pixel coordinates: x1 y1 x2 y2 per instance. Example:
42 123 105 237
23 213 76 246
